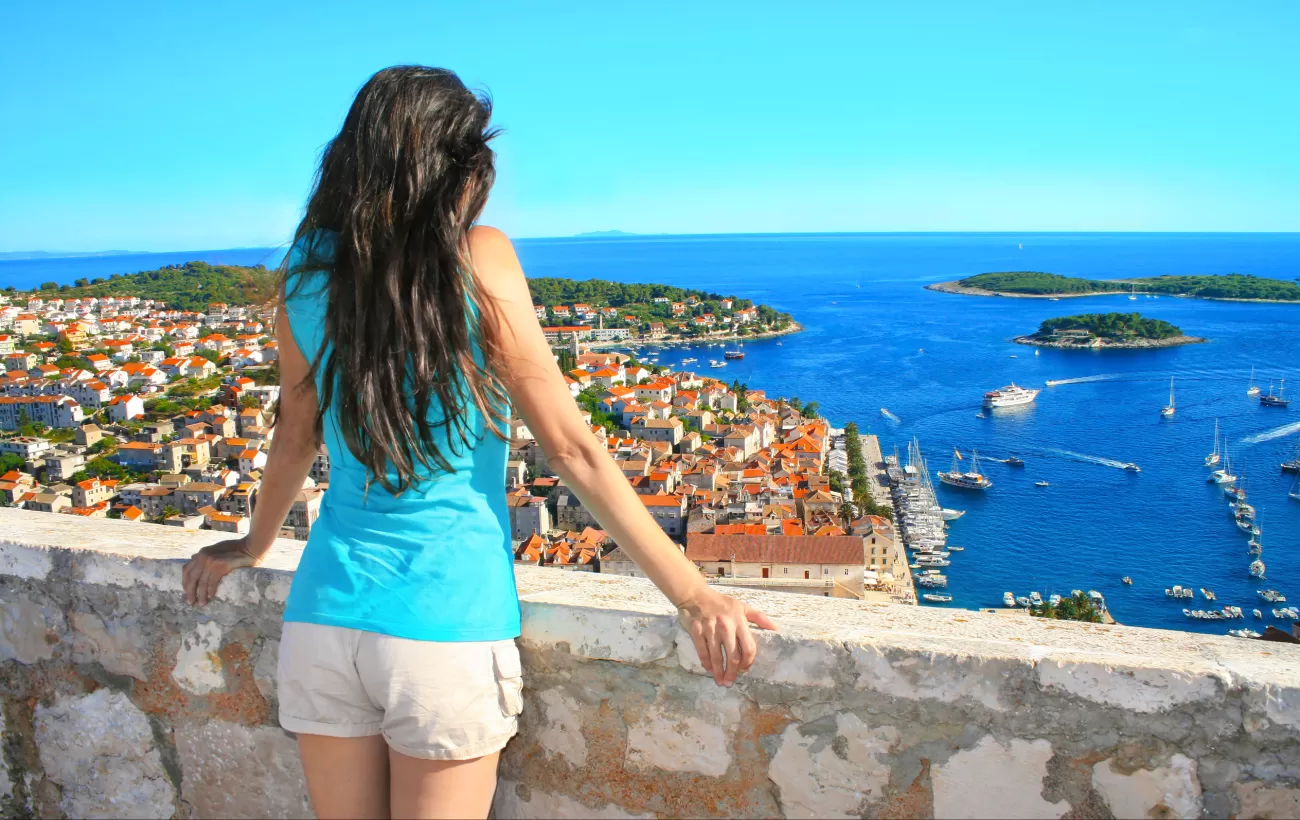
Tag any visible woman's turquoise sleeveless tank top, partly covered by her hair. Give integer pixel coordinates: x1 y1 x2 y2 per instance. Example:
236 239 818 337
285 234 519 641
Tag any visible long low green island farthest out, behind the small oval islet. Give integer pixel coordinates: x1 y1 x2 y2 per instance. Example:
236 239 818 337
926 270 1300 301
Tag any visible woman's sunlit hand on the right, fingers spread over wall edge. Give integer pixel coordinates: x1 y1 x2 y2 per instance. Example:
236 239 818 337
677 585 776 686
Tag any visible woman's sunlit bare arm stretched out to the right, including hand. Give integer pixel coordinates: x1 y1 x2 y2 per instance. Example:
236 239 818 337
471 227 775 685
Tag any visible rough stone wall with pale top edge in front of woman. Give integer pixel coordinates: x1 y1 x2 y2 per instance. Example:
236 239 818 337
0 509 1300 817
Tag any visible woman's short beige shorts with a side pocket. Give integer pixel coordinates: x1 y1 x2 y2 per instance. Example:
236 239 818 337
278 621 524 760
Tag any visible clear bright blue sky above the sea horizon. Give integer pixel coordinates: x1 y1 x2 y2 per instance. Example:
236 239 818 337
0 0 1300 251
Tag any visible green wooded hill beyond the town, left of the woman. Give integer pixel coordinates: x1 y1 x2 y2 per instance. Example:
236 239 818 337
16 263 276 312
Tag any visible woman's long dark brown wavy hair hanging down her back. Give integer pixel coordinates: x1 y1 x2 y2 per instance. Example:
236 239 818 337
282 66 507 494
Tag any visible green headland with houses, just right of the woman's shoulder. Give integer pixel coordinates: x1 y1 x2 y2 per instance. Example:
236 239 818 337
528 277 800 343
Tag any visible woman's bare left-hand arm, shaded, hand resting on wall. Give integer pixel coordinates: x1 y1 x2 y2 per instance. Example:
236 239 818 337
183 309 317 606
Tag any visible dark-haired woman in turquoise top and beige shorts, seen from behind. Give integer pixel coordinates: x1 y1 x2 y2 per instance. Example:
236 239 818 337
185 66 772 817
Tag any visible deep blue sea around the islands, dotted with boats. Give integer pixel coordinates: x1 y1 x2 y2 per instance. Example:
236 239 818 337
10 234 1300 633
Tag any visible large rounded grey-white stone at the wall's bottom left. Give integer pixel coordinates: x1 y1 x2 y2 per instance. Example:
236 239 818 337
35 689 176 820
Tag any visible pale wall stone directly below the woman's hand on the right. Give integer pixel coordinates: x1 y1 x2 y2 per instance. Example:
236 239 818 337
624 684 740 777
